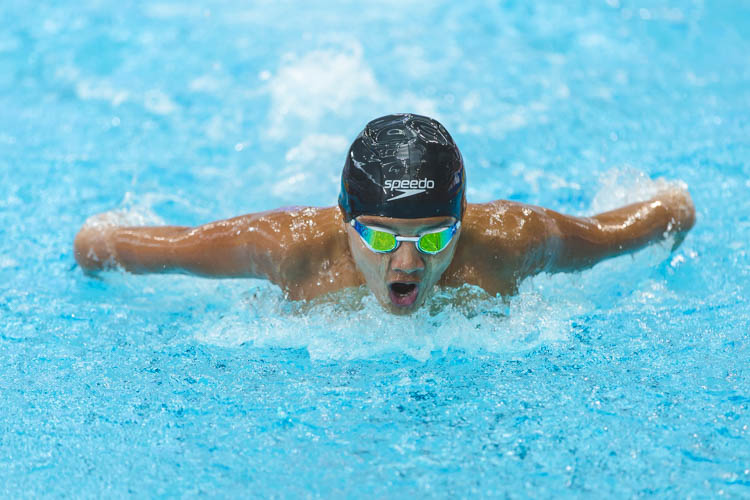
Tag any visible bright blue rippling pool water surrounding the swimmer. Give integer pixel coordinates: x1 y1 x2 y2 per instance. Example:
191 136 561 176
0 0 750 498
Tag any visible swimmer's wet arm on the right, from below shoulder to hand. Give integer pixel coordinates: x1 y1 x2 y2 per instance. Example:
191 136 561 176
538 189 695 272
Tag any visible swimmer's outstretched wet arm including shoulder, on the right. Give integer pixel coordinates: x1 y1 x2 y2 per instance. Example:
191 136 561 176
458 189 695 295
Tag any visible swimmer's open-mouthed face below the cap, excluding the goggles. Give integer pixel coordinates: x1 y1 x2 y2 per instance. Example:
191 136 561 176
346 215 460 314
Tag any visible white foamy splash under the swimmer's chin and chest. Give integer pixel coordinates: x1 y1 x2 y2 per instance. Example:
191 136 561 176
196 287 578 360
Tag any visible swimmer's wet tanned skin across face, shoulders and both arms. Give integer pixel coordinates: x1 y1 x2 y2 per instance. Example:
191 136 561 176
74 190 695 314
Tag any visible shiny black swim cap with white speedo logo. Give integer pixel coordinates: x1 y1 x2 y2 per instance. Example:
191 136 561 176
339 114 466 222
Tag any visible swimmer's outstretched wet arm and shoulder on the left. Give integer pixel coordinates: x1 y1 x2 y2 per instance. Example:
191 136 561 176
74 208 346 287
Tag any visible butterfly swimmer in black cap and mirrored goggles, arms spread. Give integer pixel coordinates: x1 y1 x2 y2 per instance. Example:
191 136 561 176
74 114 695 314
